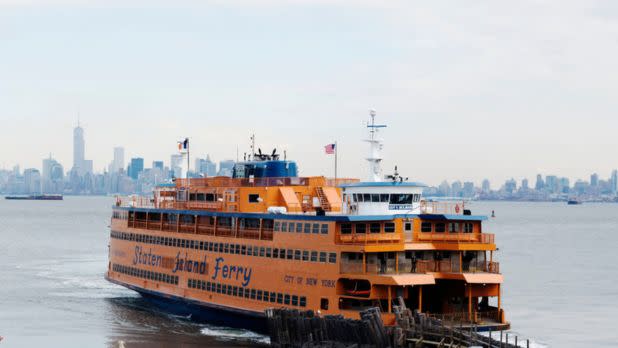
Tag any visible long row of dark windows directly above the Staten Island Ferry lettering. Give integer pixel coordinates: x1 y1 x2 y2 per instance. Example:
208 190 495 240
111 231 337 263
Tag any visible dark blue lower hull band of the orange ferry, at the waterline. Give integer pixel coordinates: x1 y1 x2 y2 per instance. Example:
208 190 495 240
107 278 268 334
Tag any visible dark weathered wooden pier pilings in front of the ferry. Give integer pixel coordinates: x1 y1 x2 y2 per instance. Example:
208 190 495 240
266 298 530 348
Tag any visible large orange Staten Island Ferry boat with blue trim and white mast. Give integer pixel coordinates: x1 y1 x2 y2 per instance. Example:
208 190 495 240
106 114 509 332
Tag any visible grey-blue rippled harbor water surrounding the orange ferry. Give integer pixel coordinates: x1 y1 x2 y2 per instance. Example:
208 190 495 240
0 197 618 348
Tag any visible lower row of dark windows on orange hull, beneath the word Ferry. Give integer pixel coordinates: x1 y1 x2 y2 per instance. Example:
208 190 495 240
187 279 307 307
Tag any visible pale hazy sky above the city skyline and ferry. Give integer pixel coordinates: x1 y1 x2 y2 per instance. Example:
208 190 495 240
0 0 618 186
